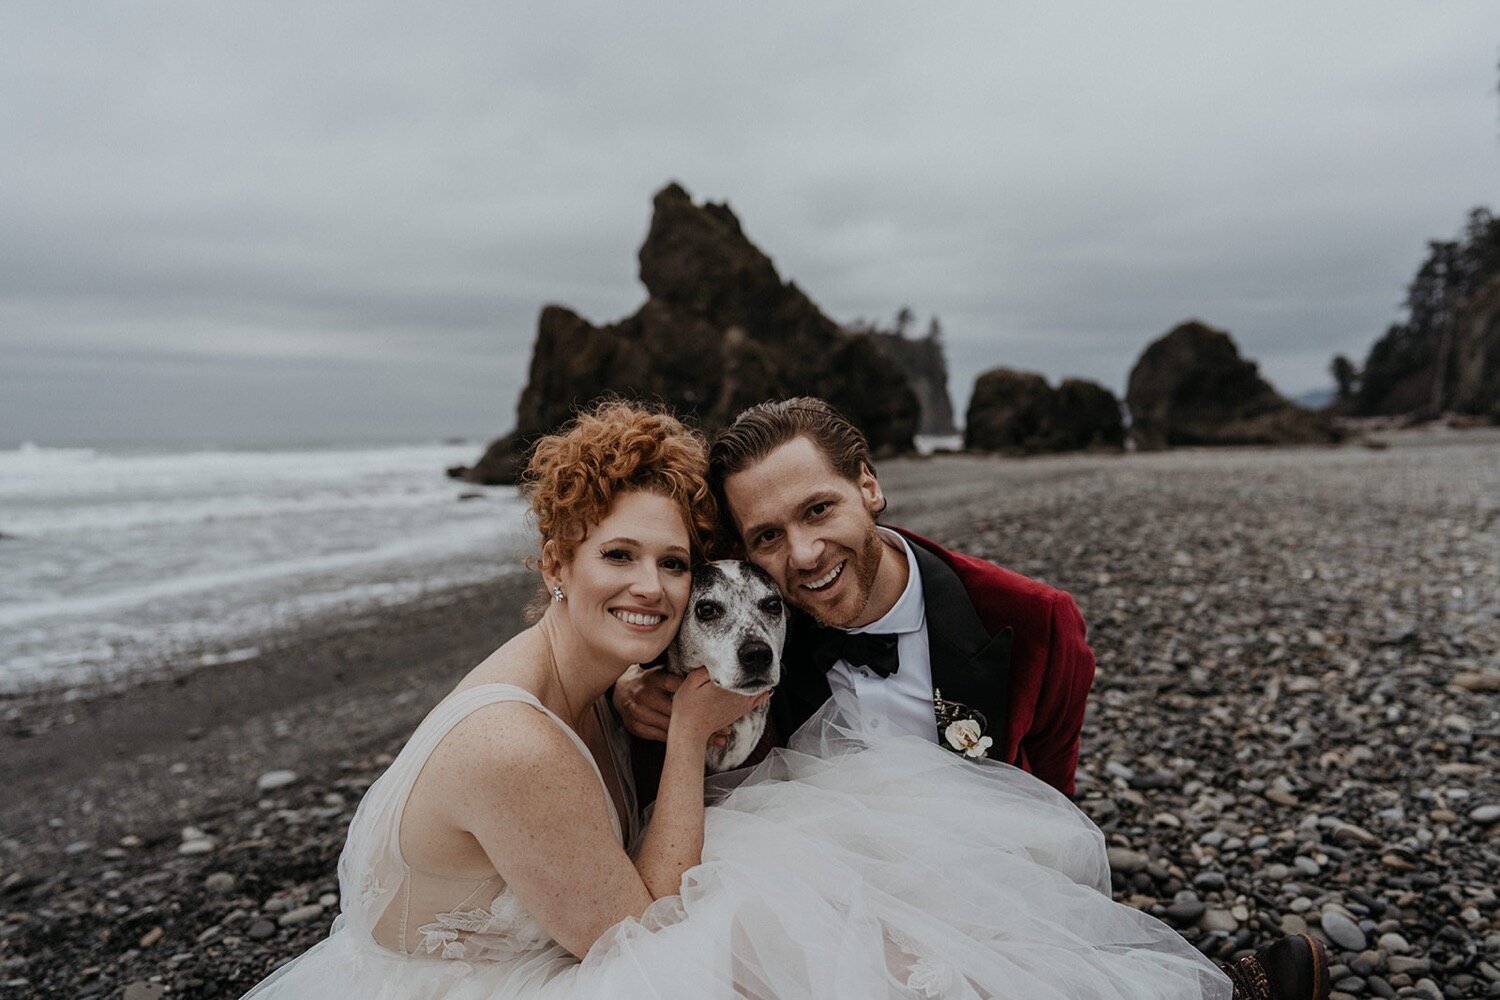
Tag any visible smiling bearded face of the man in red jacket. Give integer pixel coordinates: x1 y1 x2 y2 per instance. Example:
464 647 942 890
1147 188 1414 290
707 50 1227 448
725 438 887 628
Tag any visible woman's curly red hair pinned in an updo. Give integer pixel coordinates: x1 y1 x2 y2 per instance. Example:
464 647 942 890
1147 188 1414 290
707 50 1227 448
522 399 717 562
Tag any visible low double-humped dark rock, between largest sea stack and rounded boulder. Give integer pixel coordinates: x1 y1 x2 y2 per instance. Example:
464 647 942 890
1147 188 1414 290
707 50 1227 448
963 367 1125 454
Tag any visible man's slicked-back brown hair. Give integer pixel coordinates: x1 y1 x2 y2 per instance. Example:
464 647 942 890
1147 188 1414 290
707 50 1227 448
708 396 875 503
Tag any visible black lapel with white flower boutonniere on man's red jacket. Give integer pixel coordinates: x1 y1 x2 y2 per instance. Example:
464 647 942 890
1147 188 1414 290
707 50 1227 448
908 540 1011 744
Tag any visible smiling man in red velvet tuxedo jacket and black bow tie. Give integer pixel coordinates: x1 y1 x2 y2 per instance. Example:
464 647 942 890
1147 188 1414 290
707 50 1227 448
614 397 1094 796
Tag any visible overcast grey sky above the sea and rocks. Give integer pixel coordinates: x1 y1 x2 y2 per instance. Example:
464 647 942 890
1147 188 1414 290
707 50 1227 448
0 0 1500 444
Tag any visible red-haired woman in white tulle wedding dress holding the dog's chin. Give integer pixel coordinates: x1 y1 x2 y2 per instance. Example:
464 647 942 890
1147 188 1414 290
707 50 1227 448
248 402 1238 1000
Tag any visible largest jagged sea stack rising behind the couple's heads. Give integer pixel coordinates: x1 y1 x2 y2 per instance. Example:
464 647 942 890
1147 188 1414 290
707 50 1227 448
450 184 920 484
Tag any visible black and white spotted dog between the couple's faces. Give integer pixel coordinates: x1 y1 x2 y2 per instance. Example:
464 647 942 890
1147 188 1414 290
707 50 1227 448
666 559 786 771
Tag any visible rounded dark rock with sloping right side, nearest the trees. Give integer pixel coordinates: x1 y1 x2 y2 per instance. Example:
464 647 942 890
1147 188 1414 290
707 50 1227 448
1125 319 1341 450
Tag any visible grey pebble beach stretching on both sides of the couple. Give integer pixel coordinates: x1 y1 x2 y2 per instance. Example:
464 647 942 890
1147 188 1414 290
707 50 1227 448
0 427 1500 1000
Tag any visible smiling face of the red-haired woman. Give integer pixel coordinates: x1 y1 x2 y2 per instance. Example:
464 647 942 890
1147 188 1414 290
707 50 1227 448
558 492 693 664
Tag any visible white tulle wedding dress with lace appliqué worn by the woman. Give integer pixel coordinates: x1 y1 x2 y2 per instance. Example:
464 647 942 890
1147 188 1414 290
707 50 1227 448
248 684 1230 1000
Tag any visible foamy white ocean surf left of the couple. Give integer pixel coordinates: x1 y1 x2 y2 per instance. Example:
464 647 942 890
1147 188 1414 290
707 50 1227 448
0 444 530 694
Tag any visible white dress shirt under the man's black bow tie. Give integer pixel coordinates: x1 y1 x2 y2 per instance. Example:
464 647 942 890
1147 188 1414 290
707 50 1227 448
828 528 938 744
